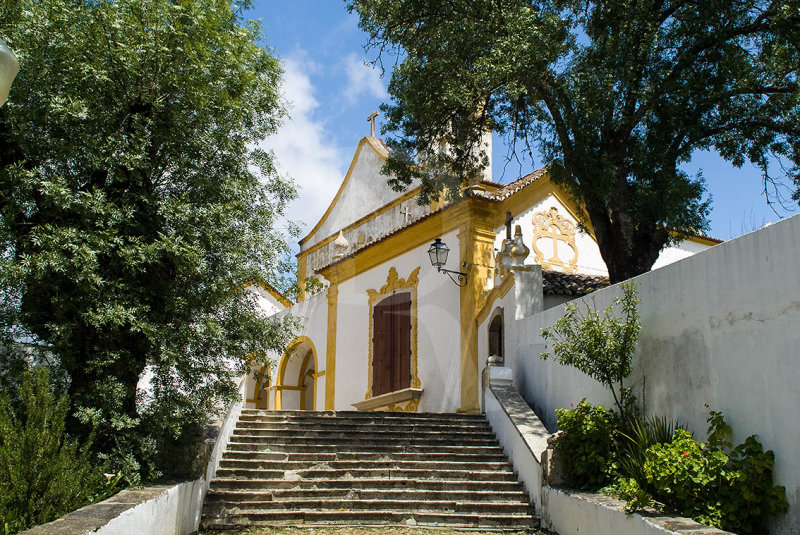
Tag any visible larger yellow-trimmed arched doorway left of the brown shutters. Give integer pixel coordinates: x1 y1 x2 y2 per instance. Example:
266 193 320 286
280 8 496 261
275 336 317 410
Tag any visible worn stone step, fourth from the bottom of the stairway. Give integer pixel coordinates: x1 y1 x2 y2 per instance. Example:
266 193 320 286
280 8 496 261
211 477 523 492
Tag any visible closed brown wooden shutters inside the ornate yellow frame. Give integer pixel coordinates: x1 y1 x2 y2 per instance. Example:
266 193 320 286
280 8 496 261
372 293 411 396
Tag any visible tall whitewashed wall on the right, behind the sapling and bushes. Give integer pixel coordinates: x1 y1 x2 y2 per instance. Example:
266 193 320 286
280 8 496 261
480 216 800 534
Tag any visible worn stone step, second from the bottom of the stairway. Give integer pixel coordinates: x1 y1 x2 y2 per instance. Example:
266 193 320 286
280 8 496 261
206 498 533 515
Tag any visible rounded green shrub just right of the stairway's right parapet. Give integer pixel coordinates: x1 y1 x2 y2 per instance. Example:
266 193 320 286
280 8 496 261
555 399 620 489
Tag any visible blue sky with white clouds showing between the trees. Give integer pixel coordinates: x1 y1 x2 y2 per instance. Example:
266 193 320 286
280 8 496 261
249 0 791 240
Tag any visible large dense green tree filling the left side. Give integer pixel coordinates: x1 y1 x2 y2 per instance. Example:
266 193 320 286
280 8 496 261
0 0 295 481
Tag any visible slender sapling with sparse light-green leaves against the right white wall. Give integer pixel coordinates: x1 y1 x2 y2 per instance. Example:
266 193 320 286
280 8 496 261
541 282 641 422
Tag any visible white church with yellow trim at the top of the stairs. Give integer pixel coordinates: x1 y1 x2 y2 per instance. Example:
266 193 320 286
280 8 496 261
246 136 718 412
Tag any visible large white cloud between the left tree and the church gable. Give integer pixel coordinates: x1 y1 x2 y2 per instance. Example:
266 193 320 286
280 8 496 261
261 52 347 241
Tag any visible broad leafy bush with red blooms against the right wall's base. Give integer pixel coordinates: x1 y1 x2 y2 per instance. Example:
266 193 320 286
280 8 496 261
618 411 788 533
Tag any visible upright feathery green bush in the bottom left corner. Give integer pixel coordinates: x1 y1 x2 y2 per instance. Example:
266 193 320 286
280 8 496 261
0 368 112 533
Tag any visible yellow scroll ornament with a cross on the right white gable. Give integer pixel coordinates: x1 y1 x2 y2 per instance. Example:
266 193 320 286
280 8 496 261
532 206 578 273
